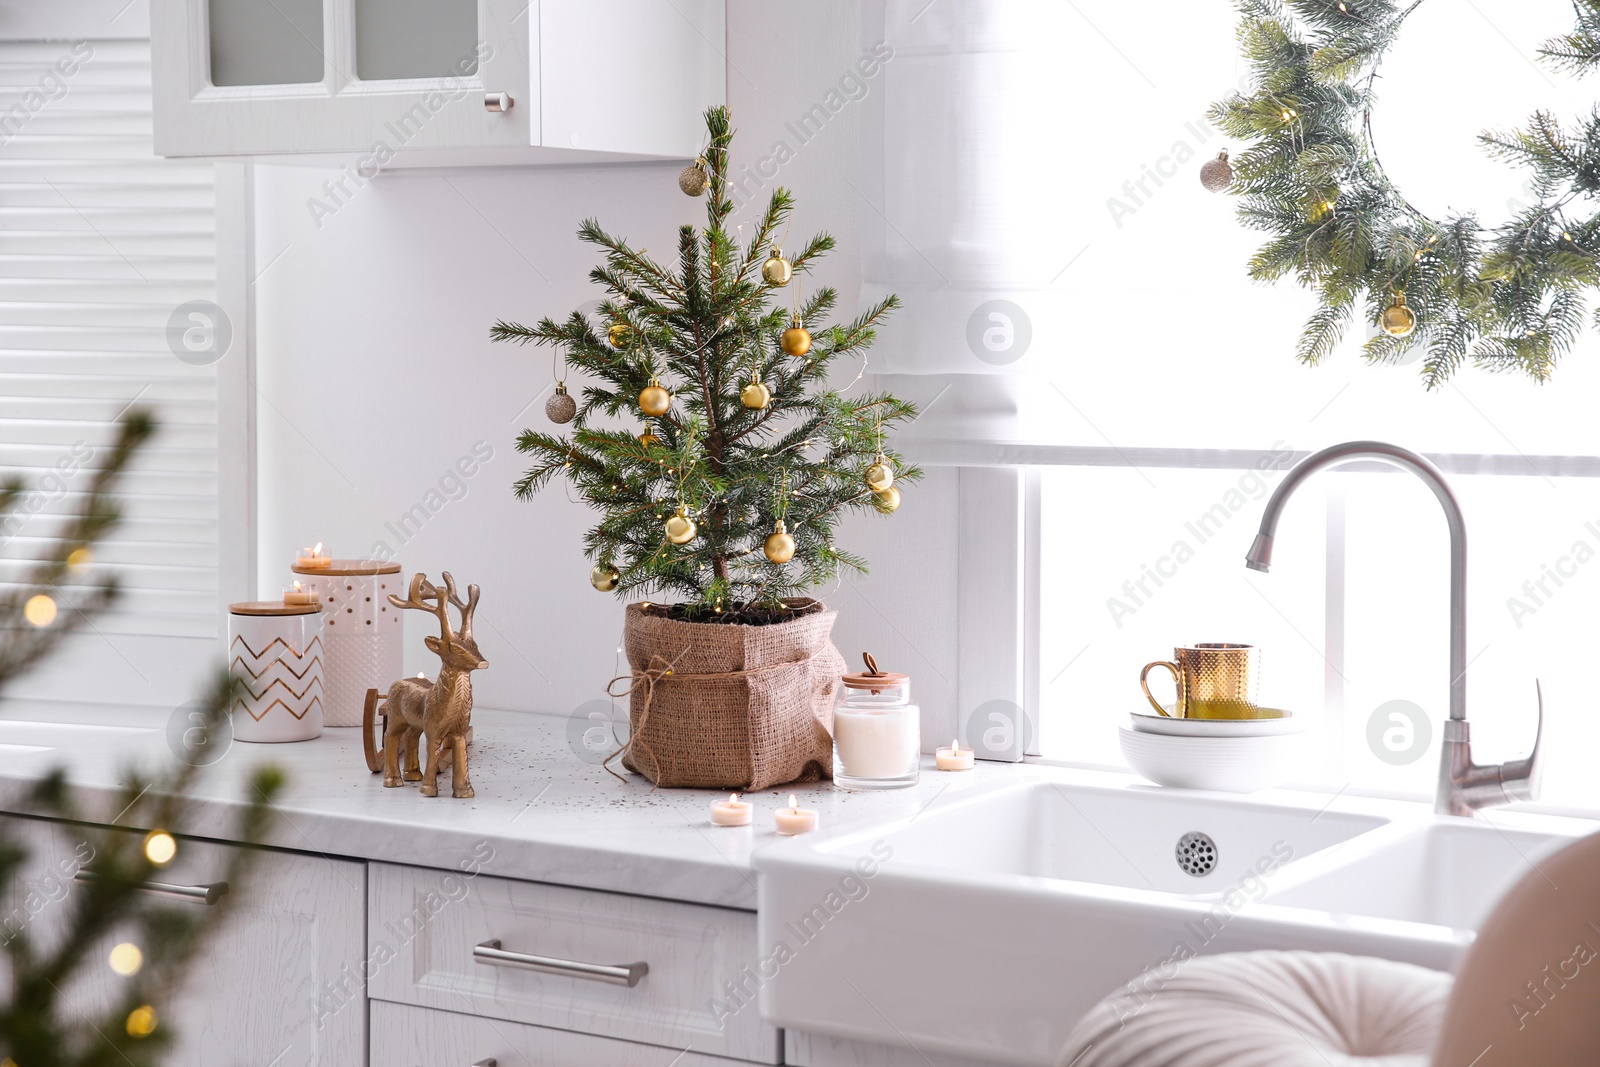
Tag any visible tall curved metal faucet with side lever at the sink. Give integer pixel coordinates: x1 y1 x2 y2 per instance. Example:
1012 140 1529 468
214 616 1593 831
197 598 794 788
1245 442 1544 816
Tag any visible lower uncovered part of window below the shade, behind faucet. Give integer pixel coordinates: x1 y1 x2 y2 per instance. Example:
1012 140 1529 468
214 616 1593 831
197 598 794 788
1040 451 1600 808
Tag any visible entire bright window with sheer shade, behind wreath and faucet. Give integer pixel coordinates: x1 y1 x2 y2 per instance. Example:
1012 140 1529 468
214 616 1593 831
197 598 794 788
1017 0 1600 809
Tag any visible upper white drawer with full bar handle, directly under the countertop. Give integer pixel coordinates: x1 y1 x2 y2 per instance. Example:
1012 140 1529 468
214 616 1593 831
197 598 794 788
366 864 779 1064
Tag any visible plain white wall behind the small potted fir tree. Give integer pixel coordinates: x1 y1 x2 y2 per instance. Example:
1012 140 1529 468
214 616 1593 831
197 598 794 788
246 0 957 726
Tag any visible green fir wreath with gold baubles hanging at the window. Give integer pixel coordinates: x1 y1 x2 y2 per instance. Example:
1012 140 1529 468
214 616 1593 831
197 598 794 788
1210 0 1600 389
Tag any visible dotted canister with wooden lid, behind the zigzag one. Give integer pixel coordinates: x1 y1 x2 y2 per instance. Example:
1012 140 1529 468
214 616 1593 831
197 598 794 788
293 560 405 726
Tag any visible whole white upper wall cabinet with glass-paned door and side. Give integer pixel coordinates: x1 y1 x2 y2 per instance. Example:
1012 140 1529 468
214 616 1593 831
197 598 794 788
150 0 726 168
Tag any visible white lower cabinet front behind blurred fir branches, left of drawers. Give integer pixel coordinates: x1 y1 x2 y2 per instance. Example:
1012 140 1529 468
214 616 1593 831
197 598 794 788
0 816 366 1067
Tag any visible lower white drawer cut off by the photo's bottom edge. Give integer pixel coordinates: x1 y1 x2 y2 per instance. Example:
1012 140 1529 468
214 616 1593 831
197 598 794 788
371 1000 774 1067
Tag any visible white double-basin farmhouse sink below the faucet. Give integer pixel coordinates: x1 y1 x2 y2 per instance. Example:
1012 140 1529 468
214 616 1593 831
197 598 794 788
754 773 1600 1067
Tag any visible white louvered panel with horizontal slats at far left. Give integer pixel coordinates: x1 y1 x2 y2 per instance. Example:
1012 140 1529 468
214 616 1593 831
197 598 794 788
0 40 218 646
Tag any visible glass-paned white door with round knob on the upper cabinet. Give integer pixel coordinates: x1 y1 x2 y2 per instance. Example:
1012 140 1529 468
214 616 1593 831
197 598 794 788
150 0 539 156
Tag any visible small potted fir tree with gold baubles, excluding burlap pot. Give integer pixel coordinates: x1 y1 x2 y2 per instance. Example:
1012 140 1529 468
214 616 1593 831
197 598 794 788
490 107 922 622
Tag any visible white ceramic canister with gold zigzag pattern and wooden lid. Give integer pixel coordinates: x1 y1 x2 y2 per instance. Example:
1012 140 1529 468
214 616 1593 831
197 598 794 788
227 600 325 741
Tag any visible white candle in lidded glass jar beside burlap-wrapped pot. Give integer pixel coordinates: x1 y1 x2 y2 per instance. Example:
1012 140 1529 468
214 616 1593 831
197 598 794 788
834 654 922 789
